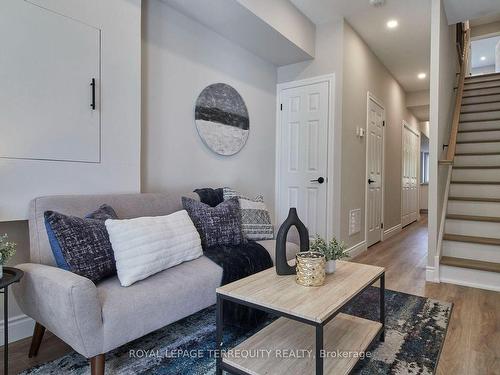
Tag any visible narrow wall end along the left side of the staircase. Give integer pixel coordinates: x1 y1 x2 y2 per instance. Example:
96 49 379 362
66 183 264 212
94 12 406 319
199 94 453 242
428 0 458 275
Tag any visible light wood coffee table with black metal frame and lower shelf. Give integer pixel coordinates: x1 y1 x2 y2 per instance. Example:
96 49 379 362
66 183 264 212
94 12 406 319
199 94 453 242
216 261 385 375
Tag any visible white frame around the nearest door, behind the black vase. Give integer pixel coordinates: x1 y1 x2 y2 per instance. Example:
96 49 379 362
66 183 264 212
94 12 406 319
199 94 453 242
274 73 340 239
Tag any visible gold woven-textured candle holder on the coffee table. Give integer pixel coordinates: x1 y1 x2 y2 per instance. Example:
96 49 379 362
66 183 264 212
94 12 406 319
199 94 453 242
295 251 326 286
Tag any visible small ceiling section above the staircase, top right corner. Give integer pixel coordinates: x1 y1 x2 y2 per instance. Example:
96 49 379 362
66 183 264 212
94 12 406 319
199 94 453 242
444 0 500 25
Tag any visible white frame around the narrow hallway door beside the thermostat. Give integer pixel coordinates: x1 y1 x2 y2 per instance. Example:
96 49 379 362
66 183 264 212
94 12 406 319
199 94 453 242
364 91 387 248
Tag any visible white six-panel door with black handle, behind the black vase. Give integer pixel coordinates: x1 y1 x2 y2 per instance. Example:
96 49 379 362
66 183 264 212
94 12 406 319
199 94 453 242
278 81 329 238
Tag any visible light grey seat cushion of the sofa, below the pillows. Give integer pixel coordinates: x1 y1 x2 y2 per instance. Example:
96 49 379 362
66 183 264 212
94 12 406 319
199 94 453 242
97 256 222 352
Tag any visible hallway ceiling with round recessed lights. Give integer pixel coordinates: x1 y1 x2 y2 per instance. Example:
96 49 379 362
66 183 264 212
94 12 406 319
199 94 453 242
290 0 432 92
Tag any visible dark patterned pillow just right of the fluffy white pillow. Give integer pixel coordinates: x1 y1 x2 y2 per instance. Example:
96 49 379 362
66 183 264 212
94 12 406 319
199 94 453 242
182 197 246 248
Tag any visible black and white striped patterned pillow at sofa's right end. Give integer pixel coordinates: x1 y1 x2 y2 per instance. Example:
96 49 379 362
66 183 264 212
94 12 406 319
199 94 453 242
224 187 274 241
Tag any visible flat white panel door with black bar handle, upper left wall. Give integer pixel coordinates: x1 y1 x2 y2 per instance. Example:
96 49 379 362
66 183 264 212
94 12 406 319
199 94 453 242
0 0 100 162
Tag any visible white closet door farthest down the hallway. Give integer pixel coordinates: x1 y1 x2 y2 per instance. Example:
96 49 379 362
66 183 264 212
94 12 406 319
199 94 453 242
401 124 420 226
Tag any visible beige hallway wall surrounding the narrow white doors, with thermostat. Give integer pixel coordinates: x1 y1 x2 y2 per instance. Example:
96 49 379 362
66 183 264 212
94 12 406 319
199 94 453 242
340 23 418 246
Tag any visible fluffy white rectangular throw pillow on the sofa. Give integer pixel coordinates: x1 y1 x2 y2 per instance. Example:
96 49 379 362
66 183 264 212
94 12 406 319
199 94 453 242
105 210 203 286
